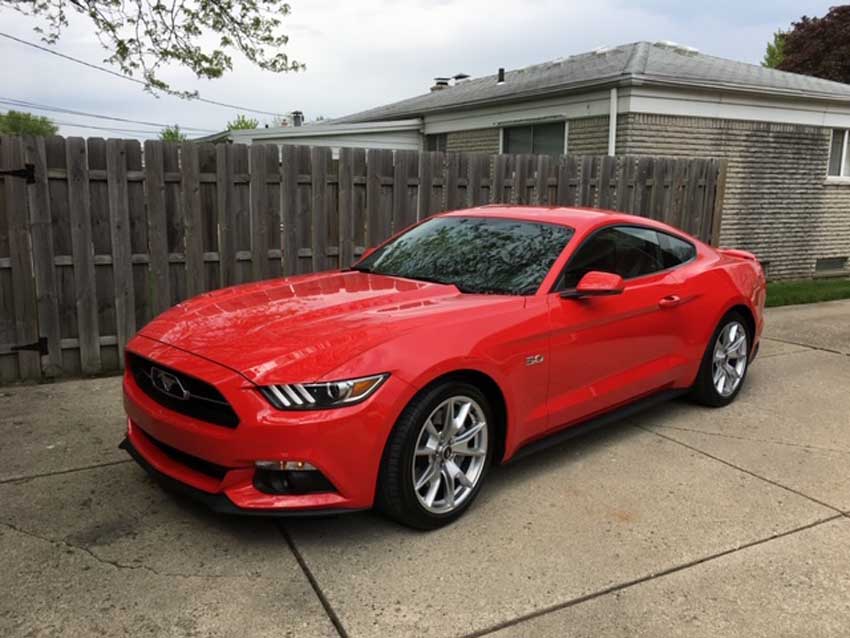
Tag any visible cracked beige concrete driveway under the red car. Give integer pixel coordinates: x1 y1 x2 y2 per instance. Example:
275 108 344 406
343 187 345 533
0 302 850 638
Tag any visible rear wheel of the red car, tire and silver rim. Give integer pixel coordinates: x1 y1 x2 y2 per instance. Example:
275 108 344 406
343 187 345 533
692 312 752 407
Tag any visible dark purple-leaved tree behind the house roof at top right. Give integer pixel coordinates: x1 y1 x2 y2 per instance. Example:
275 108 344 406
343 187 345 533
776 5 850 83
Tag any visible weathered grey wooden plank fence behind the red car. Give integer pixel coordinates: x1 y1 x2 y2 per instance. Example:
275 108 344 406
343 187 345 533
0 137 725 382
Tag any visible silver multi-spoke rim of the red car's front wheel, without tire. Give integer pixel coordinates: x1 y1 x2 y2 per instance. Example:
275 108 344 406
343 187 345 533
413 396 488 514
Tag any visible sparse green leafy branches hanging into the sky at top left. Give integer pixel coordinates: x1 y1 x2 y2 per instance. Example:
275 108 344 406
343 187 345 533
0 0 304 97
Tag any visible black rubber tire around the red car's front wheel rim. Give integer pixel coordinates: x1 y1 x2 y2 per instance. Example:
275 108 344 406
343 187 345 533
376 380 496 530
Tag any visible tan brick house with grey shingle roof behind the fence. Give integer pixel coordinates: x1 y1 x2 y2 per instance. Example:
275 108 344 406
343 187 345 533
232 42 850 278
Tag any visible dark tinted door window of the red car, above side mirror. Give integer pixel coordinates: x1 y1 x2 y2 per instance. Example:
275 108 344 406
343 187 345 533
563 226 672 289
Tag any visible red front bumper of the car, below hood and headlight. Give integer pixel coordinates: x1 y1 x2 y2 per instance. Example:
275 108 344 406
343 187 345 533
122 336 408 514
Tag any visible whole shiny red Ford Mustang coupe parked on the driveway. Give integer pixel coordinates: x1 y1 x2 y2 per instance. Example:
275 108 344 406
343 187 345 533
122 206 765 529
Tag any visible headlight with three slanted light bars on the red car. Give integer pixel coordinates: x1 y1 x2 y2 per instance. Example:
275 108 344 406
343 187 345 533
260 374 390 410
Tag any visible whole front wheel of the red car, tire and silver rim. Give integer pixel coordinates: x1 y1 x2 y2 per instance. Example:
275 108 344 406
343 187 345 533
378 381 493 529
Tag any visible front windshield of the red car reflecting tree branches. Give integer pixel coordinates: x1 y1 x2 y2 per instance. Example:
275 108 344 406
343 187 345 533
354 217 573 295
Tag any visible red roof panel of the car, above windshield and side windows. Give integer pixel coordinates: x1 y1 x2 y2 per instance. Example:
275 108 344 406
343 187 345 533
439 204 682 238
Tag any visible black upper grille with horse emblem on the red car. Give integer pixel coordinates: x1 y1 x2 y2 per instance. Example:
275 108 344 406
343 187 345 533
127 352 239 428
